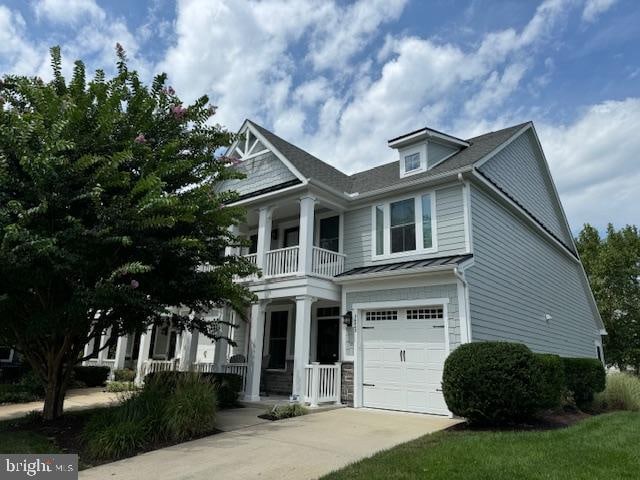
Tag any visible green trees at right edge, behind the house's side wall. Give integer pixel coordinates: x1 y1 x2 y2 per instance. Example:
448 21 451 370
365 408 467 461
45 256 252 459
576 224 640 373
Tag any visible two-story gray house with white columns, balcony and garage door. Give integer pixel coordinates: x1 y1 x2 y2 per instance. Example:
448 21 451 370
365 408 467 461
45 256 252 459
87 120 605 414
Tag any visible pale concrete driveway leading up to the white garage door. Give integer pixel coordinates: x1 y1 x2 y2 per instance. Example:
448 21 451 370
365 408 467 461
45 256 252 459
80 408 458 480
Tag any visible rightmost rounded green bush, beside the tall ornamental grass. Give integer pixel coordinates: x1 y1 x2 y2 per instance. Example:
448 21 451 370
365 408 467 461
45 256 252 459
562 358 606 407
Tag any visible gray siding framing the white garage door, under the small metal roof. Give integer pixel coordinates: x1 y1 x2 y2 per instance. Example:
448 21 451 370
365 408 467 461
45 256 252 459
346 284 460 354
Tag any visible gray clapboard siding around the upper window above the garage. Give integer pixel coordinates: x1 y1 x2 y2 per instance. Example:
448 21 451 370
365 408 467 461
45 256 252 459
344 185 466 270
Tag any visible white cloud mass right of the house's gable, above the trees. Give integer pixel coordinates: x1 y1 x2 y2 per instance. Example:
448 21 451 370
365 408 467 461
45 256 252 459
536 98 640 232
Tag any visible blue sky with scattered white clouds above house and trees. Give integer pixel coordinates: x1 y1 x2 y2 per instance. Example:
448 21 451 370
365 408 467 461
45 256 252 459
0 0 640 234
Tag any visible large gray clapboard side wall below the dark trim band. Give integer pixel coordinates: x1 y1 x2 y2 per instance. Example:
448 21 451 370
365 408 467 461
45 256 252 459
466 187 599 357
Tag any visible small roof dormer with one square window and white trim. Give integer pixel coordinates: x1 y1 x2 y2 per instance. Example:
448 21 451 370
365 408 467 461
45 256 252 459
388 128 469 178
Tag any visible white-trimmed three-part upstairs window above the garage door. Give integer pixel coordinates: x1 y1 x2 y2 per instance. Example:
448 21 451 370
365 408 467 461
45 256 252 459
372 192 437 259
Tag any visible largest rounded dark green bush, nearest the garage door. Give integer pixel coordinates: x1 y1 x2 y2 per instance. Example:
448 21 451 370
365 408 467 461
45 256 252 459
442 342 542 424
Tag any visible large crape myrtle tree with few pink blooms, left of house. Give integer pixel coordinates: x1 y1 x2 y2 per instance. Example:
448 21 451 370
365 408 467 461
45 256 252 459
0 45 254 419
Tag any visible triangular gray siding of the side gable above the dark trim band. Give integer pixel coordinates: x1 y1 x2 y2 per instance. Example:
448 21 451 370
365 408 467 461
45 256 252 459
480 131 571 245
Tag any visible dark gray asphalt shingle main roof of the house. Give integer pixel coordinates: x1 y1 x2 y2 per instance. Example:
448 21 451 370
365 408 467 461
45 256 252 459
249 120 527 193
